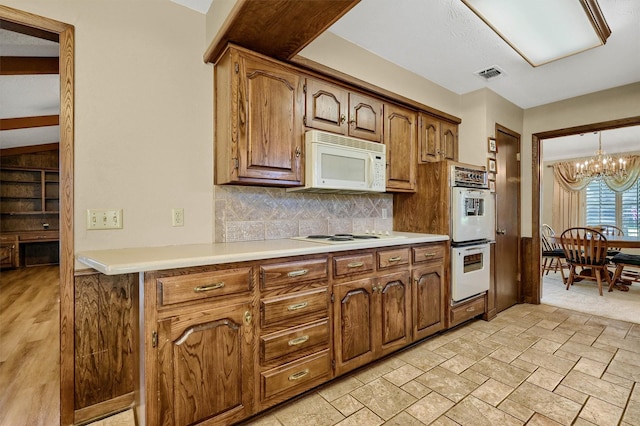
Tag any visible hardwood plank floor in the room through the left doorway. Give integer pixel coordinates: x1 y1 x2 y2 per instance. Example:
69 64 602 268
0 266 60 426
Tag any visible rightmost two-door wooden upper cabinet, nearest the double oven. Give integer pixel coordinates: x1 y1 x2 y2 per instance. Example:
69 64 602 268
418 113 458 163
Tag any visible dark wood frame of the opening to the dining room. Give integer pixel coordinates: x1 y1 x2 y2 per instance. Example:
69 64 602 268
524 116 640 304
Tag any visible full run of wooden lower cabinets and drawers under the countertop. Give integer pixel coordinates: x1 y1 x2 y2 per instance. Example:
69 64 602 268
137 243 447 426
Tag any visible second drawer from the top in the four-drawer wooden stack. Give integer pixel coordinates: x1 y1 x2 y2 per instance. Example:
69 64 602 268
260 288 329 327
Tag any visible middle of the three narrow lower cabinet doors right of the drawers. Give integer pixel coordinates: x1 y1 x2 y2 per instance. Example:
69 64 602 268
377 271 411 356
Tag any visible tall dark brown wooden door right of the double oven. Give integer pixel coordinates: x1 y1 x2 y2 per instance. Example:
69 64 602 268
494 124 520 312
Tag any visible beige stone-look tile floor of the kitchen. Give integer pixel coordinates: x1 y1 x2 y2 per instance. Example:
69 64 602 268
245 304 640 426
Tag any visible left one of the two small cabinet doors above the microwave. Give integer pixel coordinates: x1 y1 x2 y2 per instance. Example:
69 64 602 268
305 78 348 135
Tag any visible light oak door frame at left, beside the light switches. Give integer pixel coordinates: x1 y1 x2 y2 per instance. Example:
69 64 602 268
0 5 75 425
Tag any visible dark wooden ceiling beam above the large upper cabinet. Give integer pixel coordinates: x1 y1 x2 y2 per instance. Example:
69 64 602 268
204 0 360 62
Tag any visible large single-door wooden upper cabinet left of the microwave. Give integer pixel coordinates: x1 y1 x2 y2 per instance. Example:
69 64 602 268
215 47 304 186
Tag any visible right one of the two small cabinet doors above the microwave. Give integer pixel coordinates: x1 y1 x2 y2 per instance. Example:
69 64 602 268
348 93 382 142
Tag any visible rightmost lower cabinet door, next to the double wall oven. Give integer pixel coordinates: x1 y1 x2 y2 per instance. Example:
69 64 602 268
413 262 445 340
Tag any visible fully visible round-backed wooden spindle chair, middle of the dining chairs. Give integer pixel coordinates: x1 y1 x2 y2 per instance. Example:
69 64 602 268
560 228 614 296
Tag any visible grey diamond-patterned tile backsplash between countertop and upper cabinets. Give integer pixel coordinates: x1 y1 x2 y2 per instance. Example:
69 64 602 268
214 185 393 243
